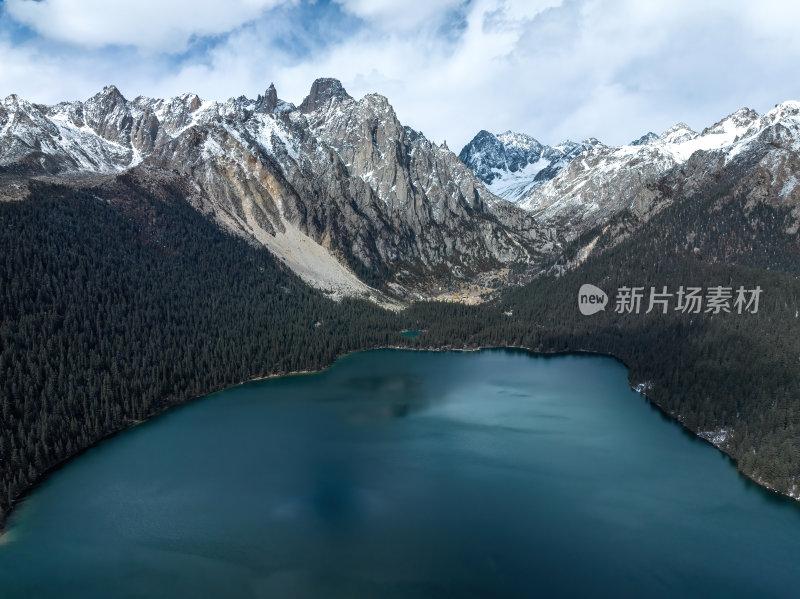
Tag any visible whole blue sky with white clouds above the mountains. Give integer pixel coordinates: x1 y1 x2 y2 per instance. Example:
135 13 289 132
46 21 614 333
0 0 800 151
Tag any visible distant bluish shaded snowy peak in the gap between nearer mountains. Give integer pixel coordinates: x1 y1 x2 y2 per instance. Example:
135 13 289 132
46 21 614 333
459 130 599 202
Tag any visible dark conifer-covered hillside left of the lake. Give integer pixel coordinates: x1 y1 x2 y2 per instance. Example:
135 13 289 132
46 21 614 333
0 177 400 521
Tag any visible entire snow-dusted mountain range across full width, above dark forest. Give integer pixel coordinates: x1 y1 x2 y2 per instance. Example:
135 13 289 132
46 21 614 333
6 79 800 301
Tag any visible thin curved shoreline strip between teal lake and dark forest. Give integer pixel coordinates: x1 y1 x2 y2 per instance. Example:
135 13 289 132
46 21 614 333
0 345 800 545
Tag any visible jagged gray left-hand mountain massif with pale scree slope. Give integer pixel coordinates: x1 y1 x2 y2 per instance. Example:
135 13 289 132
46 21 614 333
0 79 558 297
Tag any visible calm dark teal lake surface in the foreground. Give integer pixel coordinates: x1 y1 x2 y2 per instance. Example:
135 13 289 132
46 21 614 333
0 350 800 599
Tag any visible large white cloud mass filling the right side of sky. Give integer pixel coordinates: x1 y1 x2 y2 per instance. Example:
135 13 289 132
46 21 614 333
290 0 800 148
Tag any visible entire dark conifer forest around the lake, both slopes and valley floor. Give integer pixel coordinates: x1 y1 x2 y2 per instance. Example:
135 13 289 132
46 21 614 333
0 177 800 521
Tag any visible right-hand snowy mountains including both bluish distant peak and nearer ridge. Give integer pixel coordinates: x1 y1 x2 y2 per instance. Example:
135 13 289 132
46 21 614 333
460 101 800 248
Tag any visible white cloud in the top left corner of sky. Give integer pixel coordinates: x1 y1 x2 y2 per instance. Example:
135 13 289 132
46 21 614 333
5 0 294 52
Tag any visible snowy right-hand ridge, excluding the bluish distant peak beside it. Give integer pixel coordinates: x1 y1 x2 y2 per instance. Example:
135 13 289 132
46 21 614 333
518 102 800 233
